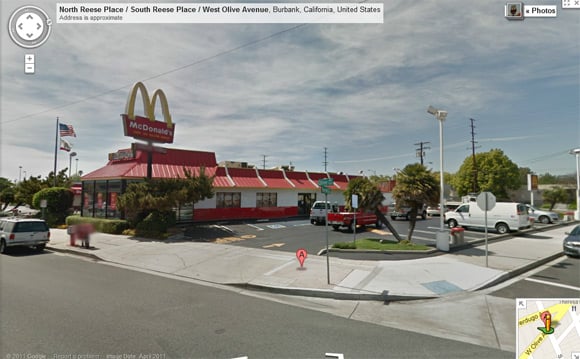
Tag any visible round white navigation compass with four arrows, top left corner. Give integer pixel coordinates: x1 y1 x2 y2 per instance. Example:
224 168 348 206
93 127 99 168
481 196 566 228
8 5 52 49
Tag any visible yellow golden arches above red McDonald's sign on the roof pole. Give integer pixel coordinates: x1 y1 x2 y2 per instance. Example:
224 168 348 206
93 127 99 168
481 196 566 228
121 82 175 143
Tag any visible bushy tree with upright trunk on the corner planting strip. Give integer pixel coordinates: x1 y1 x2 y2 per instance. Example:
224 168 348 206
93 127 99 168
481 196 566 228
393 163 440 241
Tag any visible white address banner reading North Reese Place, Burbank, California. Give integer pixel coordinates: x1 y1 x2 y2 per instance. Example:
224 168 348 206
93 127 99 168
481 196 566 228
56 3 384 24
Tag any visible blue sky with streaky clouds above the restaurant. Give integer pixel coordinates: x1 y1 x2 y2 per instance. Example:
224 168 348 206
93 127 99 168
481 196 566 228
0 0 580 180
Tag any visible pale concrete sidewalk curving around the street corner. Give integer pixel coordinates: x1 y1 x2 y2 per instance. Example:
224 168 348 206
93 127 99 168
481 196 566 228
48 226 571 301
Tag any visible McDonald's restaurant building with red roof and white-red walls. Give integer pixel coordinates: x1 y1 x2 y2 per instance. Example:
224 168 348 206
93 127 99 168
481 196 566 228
81 146 372 222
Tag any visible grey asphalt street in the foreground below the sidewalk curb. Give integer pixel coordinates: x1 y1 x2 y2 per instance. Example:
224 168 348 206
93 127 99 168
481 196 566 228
0 249 513 359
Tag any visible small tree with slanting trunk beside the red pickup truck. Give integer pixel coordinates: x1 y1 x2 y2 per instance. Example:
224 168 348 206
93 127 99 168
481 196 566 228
344 177 401 242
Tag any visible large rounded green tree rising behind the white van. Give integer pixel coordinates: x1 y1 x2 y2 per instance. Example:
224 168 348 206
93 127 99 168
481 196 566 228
452 149 520 201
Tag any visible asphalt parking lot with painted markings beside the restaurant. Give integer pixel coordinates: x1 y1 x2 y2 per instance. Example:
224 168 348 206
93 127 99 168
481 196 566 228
202 217 556 259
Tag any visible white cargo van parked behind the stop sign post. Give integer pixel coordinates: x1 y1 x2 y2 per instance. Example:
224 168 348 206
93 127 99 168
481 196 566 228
445 202 531 234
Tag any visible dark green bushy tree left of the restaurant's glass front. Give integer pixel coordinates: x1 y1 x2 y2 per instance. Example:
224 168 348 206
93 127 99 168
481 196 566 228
32 187 74 226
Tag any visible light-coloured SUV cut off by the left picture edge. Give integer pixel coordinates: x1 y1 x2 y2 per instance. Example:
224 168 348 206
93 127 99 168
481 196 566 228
0 218 50 253
